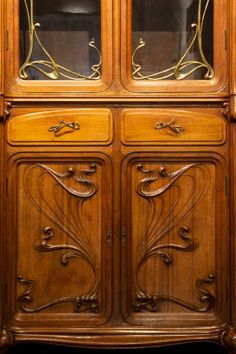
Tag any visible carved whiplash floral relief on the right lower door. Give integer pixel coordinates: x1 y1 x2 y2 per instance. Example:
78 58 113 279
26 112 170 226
134 163 215 312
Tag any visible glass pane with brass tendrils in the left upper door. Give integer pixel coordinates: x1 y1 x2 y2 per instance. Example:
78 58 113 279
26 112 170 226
19 0 101 80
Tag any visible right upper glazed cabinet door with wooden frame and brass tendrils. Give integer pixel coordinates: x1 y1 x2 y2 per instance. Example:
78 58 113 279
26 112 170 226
121 0 228 94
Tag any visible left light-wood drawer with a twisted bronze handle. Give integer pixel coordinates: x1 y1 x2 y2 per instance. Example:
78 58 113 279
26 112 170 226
7 109 112 145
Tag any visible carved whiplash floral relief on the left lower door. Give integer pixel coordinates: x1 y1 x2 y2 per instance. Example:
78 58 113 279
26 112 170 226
17 164 99 312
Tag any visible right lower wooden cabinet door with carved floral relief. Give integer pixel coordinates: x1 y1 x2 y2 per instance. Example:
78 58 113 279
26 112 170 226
122 152 228 328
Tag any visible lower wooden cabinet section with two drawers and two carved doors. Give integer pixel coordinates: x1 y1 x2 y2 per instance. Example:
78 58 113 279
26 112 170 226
0 108 236 349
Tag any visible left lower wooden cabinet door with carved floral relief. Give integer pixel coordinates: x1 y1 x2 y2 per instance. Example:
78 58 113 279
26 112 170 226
7 153 112 330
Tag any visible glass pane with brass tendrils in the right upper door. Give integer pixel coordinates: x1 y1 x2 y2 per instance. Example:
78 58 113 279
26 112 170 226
132 0 214 80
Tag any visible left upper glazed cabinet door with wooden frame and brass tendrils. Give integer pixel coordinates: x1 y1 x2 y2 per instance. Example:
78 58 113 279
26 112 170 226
5 0 112 96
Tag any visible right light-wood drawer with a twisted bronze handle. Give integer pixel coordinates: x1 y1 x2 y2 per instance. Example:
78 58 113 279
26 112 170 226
121 109 226 145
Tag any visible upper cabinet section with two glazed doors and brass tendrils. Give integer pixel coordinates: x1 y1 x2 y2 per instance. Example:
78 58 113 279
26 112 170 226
3 0 230 99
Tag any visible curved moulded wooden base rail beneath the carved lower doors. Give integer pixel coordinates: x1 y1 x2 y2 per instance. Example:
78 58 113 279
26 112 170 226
0 328 233 353
